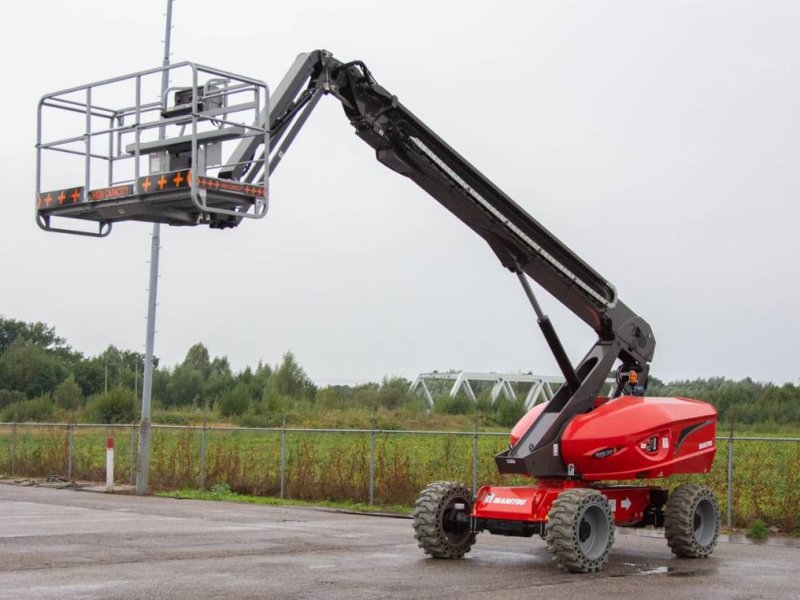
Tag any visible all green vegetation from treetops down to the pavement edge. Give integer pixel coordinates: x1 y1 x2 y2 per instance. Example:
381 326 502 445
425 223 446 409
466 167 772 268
0 317 800 533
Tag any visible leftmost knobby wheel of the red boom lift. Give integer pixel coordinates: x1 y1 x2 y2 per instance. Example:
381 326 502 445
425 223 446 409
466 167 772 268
414 481 475 558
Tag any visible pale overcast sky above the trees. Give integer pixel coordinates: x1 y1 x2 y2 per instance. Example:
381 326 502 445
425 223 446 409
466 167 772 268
0 0 800 385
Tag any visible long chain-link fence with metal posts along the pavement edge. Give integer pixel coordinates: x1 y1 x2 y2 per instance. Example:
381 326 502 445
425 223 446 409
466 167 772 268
0 423 800 533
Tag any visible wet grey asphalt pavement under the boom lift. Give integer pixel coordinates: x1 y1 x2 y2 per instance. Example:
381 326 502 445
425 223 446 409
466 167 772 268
0 485 800 600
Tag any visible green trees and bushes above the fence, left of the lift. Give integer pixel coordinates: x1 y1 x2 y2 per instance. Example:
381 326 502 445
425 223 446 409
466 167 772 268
0 317 506 430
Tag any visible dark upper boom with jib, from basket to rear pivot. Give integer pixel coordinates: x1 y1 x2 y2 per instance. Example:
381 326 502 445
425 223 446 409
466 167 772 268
233 50 655 365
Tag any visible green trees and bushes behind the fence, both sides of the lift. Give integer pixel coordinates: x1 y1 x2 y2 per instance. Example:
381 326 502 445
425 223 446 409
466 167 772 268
0 317 800 428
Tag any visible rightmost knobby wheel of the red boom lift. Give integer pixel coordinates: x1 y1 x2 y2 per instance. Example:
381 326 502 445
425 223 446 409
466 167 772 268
664 484 720 558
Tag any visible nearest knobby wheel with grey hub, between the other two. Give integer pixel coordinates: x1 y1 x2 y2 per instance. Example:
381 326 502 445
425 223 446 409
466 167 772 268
546 488 614 573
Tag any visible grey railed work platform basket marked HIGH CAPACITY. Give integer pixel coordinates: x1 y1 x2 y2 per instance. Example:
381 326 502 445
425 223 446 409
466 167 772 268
36 62 269 236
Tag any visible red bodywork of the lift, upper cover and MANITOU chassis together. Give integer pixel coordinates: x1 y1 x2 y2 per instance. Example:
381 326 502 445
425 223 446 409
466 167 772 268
471 396 717 535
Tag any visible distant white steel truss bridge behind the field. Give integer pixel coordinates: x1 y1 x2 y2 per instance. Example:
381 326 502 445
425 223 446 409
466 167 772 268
411 371 614 409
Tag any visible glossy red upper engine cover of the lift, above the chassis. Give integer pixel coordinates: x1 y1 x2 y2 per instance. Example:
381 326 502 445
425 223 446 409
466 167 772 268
511 396 717 481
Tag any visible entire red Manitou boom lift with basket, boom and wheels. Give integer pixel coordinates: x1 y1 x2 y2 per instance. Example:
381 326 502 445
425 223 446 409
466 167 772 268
36 50 720 572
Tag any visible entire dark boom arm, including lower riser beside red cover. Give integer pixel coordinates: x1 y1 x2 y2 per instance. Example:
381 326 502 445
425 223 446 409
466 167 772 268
222 50 655 476
